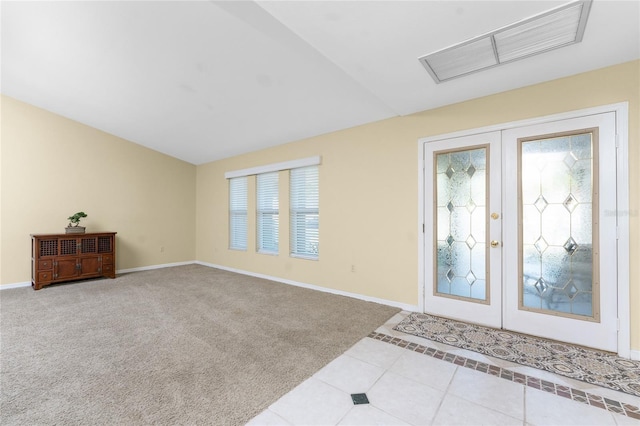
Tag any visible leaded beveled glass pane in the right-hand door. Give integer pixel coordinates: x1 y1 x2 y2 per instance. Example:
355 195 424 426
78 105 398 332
519 133 595 317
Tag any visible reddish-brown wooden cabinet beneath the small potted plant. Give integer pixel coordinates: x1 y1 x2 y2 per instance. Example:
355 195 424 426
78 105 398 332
31 232 116 290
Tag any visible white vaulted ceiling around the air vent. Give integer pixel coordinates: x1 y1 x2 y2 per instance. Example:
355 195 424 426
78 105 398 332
0 0 640 164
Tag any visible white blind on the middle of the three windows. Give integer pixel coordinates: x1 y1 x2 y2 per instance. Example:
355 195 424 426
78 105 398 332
256 172 279 253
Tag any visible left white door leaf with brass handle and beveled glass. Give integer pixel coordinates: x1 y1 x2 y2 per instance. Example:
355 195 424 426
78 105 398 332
424 132 502 327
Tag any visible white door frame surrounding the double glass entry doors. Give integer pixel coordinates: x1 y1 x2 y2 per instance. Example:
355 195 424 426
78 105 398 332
417 102 631 358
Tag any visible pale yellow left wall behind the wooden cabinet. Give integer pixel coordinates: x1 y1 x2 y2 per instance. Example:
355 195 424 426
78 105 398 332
0 96 196 284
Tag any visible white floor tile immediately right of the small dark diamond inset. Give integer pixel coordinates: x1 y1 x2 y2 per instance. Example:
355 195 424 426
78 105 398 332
367 372 444 425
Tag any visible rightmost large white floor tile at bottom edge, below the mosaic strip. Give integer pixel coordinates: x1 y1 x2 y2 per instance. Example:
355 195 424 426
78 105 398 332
525 387 616 426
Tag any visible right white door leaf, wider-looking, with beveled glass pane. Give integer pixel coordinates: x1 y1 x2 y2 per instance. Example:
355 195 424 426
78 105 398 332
502 113 618 352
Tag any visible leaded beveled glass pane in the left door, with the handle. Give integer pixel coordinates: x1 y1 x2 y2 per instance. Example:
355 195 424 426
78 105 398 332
434 147 489 301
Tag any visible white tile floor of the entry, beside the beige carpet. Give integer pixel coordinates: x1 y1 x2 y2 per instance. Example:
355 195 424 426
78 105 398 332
249 312 640 426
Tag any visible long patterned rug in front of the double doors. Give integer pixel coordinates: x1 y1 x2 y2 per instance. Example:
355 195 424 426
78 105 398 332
394 313 640 396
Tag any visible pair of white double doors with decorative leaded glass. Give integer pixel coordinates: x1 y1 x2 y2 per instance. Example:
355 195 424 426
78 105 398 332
424 113 617 351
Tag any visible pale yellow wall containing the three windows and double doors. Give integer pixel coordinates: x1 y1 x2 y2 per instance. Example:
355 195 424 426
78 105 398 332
196 61 640 350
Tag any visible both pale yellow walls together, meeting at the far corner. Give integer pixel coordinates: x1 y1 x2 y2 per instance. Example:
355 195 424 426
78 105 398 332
0 61 640 350
